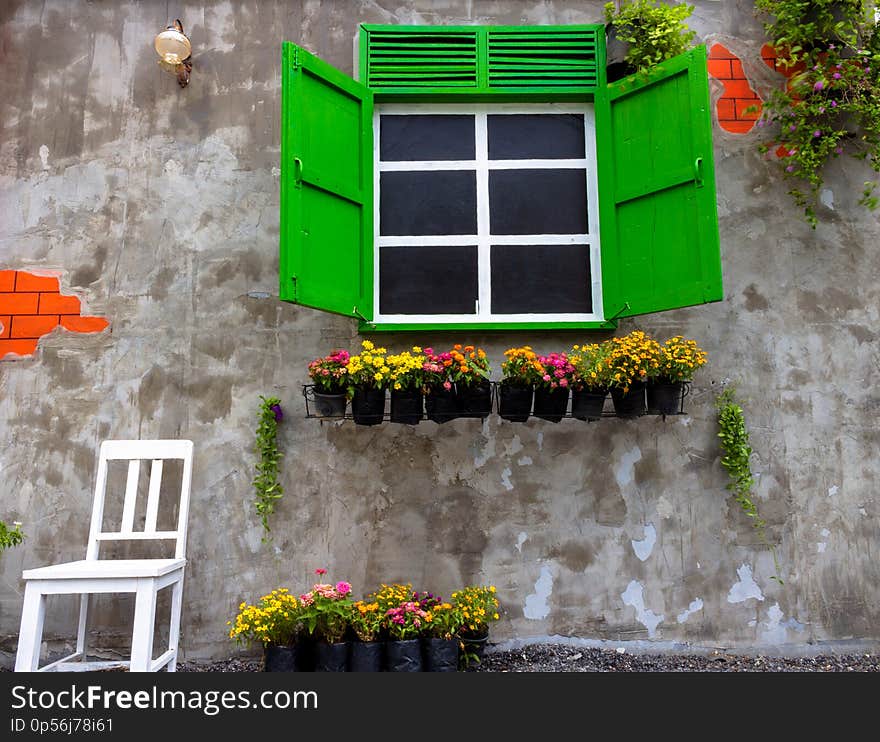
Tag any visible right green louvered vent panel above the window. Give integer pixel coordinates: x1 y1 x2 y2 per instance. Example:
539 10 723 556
487 26 601 90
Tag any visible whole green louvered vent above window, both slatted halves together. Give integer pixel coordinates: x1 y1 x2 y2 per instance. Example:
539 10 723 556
360 24 604 96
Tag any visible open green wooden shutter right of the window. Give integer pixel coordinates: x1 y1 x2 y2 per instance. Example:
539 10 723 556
596 46 723 319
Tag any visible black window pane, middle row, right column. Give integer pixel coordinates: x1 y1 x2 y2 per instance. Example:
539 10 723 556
489 169 587 234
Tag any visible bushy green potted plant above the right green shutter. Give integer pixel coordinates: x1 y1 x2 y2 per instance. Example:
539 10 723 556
605 0 695 82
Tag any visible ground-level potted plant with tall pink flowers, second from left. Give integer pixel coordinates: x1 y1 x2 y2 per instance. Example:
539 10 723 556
299 569 352 672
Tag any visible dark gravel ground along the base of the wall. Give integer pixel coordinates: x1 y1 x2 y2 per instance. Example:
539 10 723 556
177 644 880 672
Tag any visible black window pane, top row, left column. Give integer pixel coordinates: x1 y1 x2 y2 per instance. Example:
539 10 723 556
379 114 475 162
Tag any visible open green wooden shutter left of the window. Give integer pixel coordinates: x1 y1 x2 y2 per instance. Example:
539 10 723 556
279 41 373 320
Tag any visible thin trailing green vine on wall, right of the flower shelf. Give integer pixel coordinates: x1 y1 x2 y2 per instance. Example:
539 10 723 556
715 387 784 585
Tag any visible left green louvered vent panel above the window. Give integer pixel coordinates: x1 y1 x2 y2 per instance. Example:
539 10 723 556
366 26 477 90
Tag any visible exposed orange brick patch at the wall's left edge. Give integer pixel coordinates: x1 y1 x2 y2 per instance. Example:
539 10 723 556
0 270 110 360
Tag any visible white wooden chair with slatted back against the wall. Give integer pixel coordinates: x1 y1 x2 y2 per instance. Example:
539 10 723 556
15 440 193 672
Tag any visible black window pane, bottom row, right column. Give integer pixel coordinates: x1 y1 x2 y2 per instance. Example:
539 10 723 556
492 245 593 314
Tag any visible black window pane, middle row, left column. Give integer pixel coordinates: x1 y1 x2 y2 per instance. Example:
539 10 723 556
379 170 477 235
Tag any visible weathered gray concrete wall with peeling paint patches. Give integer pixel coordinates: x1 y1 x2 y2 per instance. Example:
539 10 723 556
0 0 880 663
